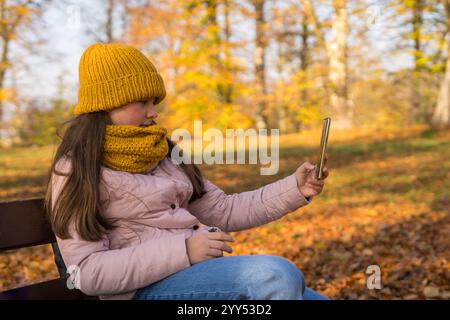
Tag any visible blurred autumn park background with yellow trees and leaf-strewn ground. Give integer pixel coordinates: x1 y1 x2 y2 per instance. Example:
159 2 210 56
0 0 450 299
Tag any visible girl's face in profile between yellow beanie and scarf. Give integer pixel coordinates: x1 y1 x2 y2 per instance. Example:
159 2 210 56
109 99 158 127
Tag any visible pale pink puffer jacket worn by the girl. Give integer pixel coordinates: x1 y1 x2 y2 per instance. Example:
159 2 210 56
52 158 311 299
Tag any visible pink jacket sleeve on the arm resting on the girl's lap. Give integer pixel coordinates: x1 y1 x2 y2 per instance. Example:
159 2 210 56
52 159 190 295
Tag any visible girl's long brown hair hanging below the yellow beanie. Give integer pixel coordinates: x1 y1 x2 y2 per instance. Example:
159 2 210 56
44 111 205 241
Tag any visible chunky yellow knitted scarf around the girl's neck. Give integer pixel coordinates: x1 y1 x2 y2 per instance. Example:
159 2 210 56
103 125 169 173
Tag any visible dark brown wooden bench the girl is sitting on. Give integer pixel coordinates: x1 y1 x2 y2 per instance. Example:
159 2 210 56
0 198 98 300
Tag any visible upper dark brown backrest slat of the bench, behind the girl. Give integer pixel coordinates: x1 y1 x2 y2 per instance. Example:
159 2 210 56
0 198 56 251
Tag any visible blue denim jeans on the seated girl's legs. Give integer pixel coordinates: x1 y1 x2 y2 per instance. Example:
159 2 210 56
133 255 327 300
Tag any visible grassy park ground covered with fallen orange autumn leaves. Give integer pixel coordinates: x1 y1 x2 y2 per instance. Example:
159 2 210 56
0 127 450 299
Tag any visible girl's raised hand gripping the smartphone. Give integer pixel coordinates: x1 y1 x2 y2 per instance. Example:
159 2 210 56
295 157 329 198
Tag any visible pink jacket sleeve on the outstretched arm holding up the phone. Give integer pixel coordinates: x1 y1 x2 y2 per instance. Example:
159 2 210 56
188 174 311 232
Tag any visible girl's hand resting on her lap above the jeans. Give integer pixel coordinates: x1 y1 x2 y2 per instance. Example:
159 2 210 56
186 231 234 264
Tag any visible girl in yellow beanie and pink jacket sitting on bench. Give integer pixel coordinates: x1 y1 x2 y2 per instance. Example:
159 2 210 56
45 44 328 299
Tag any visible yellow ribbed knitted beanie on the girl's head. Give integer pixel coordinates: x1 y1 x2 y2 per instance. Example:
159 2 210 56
73 43 166 115
